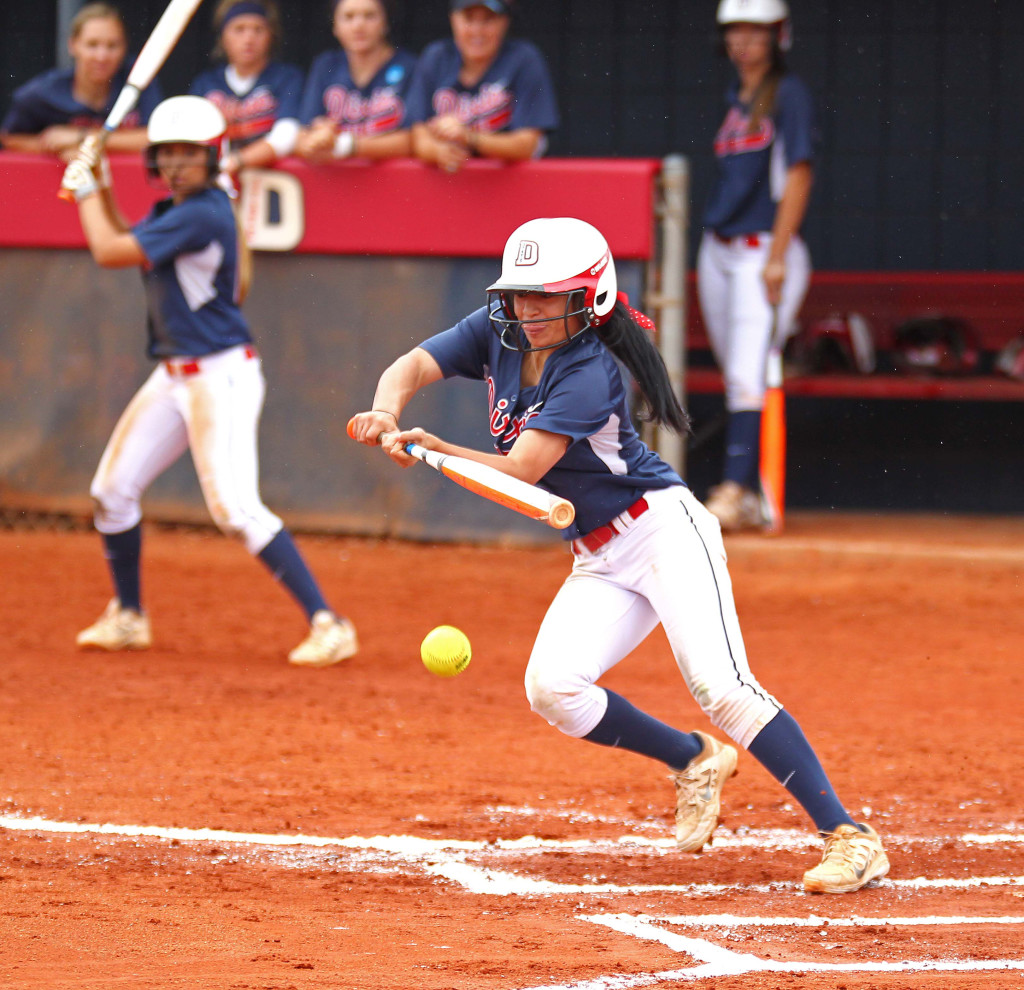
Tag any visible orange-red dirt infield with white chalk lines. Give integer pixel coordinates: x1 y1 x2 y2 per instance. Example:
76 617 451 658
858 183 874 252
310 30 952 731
0 514 1024 990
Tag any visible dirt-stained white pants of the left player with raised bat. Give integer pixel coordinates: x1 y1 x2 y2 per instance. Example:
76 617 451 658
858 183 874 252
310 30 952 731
90 347 282 554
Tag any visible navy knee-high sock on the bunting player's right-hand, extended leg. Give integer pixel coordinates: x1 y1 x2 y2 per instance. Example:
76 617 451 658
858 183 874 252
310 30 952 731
748 711 854 832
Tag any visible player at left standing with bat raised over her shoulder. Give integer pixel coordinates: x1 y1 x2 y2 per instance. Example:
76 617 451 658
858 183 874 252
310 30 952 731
63 96 356 666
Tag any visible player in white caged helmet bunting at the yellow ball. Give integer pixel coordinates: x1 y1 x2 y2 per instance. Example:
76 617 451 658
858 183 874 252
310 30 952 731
353 217 889 893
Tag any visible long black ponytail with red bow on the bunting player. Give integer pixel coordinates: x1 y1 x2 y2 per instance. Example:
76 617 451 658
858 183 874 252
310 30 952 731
593 297 690 436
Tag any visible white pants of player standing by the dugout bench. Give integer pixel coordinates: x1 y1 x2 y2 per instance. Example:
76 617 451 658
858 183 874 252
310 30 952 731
697 232 811 413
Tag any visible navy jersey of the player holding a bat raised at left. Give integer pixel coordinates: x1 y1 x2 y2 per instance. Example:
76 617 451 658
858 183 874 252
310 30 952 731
132 187 252 357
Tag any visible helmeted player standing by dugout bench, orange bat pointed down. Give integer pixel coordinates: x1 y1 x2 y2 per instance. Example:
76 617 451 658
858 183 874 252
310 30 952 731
697 0 814 530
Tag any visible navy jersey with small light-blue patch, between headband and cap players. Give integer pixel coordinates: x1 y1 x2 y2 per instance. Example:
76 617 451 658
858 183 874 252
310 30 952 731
299 48 416 135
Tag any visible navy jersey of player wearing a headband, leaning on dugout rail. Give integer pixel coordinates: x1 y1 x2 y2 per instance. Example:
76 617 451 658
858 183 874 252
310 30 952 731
189 61 304 147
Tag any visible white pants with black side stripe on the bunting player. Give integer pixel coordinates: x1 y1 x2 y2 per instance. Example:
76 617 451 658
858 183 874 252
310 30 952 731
526 486 781 748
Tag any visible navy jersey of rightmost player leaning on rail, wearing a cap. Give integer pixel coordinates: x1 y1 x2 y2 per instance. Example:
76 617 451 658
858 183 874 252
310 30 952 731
409 38 558 132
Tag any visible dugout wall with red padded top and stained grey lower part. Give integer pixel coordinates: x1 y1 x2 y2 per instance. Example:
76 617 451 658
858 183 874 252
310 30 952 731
0 155 660 542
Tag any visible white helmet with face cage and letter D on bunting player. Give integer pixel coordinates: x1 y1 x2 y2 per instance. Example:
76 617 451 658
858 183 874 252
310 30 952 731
487 217 618 350
